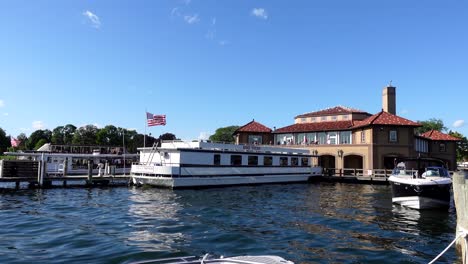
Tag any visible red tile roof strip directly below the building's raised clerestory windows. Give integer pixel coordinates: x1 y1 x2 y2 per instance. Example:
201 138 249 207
273 121 353 133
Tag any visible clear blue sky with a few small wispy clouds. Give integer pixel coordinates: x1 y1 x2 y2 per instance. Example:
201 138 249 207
0 0 468 139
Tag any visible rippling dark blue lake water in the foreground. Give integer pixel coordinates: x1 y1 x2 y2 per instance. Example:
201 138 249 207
0 183 461 263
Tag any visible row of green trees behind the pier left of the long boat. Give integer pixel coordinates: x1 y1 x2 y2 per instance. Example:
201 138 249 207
0 124 176 154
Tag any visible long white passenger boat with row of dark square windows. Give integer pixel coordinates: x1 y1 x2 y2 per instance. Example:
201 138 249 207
131 141 322 188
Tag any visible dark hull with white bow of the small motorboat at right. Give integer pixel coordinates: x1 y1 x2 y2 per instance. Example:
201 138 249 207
390 179 451 209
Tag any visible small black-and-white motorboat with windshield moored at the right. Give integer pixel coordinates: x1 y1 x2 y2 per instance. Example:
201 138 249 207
388 158 452 209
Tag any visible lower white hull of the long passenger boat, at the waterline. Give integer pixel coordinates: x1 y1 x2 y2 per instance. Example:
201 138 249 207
132 174 317 188
